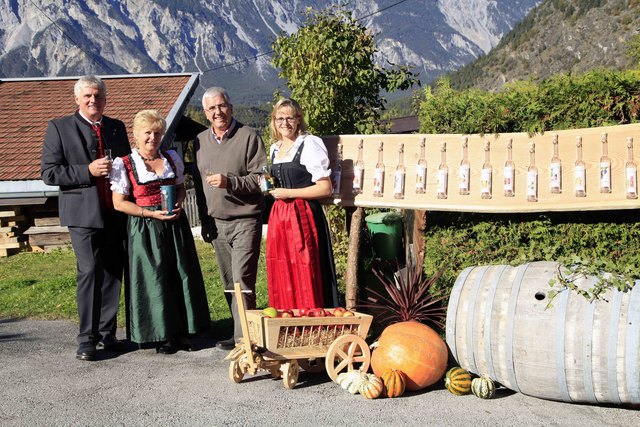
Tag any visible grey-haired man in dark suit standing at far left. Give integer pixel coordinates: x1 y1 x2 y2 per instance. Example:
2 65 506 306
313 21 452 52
41 76 131 360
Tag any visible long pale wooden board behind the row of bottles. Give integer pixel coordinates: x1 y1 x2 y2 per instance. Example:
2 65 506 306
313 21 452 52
323 124 640 213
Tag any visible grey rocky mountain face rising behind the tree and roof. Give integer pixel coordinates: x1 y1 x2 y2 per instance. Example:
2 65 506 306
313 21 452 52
0 0 541 104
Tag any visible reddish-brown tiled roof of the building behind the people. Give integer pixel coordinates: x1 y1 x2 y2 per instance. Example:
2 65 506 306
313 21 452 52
0 73 199 184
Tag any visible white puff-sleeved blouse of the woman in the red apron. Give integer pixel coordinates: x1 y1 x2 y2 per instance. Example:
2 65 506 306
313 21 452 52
269 134 331 182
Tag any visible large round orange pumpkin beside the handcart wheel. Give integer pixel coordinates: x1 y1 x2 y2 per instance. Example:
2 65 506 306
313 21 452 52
371 320 448 391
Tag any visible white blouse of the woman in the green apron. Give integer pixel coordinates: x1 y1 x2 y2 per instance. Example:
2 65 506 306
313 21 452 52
109 150 184 196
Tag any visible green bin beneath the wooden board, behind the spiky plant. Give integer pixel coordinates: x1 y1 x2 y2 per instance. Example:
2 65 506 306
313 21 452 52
364 212 404 259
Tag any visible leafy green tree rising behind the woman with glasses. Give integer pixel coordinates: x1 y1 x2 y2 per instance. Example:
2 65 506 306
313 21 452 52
272 5 419 135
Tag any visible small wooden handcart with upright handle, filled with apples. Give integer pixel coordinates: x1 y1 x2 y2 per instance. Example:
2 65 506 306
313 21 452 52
225 283 373 389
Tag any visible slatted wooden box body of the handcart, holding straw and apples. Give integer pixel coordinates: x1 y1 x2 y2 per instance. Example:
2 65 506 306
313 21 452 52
246 310 373 358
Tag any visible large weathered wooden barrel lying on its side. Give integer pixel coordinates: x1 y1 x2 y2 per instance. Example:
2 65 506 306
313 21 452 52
446 262 640 405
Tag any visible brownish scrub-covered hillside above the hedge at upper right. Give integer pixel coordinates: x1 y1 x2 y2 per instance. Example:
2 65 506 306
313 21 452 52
450 0 640 90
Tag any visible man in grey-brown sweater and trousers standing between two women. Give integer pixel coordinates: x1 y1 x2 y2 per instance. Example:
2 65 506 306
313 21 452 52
194 87 267 350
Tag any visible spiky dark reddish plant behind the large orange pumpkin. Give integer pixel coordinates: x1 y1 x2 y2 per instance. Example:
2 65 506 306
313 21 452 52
361 263 447 331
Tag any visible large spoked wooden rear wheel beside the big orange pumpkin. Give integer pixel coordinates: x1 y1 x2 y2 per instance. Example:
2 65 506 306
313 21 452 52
325 334 371 382
